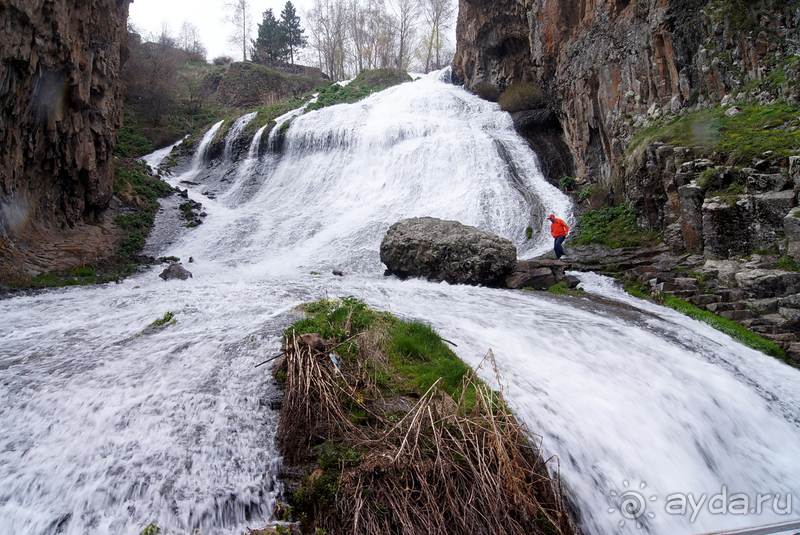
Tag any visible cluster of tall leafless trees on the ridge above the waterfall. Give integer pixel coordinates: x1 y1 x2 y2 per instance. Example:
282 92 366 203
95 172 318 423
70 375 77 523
306 0 456 80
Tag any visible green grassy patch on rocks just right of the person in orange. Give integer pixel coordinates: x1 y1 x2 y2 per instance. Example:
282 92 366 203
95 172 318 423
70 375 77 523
572 204 659 248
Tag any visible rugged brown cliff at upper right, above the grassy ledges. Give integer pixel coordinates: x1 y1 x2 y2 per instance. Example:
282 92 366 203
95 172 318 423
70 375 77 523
454 0 800 182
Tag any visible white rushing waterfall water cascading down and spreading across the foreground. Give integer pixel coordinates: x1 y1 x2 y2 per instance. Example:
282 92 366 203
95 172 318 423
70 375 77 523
0 71 800 535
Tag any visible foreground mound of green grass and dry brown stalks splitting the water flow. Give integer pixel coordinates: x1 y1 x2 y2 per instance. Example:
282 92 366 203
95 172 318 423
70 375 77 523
276 297 575 535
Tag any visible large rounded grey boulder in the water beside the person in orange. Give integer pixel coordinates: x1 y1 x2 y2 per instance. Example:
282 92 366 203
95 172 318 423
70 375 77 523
381 217 517 286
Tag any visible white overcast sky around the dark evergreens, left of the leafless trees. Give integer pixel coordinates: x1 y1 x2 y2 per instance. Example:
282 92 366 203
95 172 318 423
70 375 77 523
128 0 314 61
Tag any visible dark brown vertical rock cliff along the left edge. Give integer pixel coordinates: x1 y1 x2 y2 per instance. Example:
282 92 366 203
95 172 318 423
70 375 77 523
0 0 130 278
